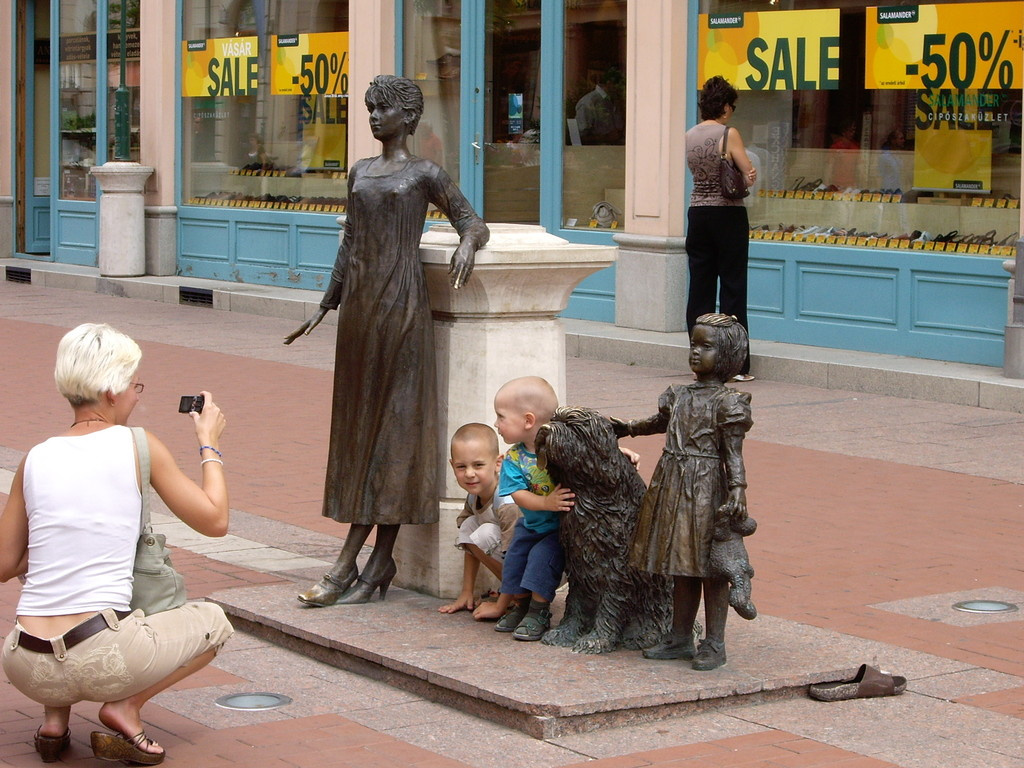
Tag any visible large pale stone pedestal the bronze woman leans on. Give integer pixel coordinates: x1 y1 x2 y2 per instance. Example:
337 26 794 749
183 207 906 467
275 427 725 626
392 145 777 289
395 224 616 596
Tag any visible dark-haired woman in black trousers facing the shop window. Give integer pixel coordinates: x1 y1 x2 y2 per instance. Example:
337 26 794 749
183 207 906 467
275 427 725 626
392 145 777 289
686 75 758 381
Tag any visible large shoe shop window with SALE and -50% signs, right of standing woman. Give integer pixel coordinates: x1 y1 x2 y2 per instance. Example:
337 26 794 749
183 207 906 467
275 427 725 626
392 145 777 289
695 0 1024 257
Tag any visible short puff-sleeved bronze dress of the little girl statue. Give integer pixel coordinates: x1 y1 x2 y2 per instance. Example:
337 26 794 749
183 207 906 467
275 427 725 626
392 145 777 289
630 381 753 579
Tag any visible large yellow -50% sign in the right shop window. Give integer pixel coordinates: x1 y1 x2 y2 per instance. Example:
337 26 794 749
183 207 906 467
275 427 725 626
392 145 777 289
864 2 1024 90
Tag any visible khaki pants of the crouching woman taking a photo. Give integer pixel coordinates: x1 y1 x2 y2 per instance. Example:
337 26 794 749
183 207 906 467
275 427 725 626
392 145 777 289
2 602 234 707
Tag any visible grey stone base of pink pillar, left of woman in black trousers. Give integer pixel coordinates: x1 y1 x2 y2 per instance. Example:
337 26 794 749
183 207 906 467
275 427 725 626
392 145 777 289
613 232 686 333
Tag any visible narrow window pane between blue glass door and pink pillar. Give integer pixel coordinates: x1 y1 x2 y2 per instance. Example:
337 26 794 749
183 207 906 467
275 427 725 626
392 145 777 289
562 0 626 228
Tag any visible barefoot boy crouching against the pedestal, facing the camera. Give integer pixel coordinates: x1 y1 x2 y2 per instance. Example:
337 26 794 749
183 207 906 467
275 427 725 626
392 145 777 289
437 424 519 618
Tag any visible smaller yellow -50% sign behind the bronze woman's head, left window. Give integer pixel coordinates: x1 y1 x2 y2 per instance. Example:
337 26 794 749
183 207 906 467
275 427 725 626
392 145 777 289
270 32 348 96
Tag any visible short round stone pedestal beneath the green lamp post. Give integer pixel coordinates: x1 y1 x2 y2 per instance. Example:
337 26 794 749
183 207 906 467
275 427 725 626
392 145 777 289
90 162 153 278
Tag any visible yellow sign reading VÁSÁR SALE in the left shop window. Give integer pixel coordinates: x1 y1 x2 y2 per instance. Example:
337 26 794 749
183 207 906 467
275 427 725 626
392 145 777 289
181 37 259 96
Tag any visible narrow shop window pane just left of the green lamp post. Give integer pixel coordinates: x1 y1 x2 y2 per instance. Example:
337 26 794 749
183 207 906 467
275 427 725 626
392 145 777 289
57 0 97 200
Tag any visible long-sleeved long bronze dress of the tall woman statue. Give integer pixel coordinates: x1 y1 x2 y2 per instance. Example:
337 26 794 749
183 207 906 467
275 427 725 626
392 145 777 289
321 157 487 525
